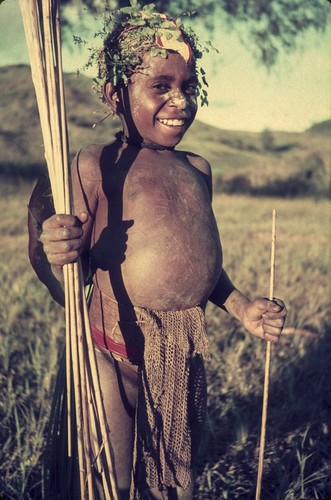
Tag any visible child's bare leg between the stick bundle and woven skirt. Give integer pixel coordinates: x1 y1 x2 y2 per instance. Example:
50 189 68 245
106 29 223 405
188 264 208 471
96 347 138 499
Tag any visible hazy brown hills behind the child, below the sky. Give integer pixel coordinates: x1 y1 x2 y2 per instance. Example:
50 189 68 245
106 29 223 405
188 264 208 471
0 65 331 195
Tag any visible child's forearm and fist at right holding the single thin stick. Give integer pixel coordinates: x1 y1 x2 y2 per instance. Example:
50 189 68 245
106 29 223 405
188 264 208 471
209 270 287 342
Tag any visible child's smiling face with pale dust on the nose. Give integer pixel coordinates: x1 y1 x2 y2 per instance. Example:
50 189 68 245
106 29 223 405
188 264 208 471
123 52 198 147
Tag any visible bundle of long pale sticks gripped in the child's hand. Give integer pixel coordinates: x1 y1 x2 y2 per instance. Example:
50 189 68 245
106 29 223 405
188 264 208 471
19 0 118 500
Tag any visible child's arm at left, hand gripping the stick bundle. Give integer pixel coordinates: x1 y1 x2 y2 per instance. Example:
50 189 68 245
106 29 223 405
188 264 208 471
28 146 97 305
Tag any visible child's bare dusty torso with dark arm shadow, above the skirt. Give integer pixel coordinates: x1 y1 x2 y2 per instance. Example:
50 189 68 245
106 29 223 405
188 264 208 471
75 142 222 310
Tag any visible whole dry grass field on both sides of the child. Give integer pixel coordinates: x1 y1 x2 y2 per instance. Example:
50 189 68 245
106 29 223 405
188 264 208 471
0 179 331 500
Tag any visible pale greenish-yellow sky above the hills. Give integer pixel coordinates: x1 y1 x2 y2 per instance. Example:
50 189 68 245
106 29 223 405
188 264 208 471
0 0 331 132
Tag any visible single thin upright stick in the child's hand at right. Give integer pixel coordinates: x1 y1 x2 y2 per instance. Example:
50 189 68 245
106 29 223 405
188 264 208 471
255 209 276 500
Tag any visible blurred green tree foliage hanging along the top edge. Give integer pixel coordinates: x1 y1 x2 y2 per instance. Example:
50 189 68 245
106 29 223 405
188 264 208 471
62 0 331 67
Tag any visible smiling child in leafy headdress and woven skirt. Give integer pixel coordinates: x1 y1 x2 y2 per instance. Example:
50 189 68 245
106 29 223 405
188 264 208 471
29 4 286 499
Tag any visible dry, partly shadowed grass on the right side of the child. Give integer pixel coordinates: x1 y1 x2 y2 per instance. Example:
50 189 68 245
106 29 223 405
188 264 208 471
199 196 331 500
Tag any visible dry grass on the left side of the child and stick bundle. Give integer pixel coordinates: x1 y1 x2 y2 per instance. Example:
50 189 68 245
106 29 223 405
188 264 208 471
0 180 64 499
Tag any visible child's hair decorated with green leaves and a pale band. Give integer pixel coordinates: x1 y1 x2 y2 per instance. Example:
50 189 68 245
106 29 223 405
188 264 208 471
76 1 217 105
